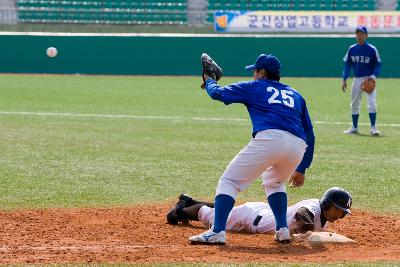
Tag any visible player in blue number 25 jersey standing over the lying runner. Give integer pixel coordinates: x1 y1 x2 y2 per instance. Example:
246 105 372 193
189 54 315 244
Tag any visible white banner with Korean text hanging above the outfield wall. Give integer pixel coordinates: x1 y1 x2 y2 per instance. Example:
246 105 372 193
214 11 400 33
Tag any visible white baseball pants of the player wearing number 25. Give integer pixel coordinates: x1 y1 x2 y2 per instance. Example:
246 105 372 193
216 129 307 199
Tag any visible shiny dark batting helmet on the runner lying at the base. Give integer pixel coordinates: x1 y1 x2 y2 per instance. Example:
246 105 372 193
321 187 352 215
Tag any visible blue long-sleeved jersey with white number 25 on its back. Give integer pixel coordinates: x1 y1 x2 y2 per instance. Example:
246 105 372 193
206 79 313 142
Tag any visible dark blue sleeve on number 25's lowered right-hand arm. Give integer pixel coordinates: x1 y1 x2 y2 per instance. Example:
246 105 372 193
296 100 315 173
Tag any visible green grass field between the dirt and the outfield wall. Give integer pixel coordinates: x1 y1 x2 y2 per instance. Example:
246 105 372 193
0 75 400 218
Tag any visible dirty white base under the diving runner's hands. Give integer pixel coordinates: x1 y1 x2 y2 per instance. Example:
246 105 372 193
293 232 356 244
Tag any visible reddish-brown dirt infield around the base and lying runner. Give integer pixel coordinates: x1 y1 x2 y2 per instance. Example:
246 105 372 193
0 202 400 264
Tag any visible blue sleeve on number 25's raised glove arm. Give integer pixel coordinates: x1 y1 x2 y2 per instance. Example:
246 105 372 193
206 79 250 105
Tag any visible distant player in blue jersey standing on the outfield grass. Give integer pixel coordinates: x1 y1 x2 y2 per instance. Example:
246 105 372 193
342 26 381 136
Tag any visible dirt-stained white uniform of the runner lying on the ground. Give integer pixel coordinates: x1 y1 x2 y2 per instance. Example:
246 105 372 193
198 199 326 233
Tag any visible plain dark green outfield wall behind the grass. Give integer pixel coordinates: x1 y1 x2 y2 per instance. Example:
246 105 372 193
0 35 400 77
